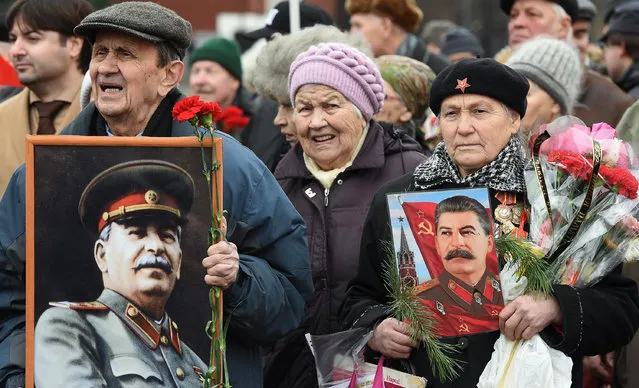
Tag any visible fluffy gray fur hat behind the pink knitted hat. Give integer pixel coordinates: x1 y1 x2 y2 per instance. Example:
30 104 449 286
251 25 372 103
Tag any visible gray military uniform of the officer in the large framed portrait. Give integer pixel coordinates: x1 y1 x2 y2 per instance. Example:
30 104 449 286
35 289 207 387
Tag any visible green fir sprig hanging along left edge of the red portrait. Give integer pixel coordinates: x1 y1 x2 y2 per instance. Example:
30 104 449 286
382 242 461 382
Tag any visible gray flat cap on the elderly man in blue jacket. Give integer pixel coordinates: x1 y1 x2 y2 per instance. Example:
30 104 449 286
73 1 192 58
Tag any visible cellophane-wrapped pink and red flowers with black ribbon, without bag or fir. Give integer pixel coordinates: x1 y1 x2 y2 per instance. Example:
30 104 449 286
525 117 639 287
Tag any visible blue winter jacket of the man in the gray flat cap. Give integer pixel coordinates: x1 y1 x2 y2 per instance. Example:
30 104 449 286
0 96 313 388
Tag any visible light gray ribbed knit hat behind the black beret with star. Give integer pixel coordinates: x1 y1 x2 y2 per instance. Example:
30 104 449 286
506 37 582 114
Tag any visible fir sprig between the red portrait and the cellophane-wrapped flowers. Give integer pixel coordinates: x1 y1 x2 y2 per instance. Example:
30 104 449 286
495 235 553 295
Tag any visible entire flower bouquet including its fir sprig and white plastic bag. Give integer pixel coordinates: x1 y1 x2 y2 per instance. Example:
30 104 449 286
477 117 639 388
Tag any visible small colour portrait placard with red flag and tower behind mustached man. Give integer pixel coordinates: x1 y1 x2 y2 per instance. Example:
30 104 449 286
387 188 504 337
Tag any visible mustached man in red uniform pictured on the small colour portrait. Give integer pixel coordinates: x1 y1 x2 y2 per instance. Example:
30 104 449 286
418 195 504 337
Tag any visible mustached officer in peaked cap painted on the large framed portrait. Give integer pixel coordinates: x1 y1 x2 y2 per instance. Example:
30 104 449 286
34 160 207 388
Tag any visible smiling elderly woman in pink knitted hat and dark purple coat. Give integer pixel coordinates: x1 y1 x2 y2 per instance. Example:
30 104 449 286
265 43 425 387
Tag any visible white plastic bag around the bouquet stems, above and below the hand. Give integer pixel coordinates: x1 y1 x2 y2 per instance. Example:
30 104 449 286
477 264 572 388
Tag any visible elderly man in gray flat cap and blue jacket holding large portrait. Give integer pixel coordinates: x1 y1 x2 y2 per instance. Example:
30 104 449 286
0 2 313 388
